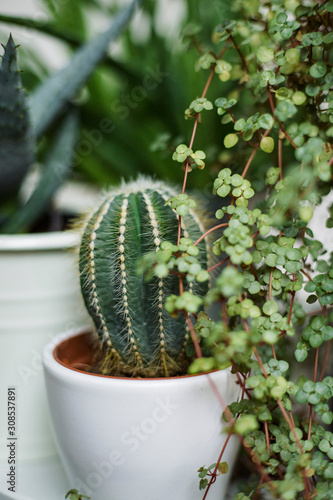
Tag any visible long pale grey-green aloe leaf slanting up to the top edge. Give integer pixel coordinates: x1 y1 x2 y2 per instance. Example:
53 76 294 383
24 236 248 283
30 0 141 137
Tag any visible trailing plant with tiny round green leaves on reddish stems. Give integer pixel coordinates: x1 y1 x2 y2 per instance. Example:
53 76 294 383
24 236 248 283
44 0 333 500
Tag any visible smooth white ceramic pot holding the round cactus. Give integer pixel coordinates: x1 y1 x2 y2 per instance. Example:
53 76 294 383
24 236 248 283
43 332 240 500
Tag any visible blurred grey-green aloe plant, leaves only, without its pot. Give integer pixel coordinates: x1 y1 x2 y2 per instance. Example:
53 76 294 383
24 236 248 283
0 0 140 233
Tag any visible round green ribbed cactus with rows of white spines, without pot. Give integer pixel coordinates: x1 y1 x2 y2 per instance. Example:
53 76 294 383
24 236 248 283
80 178 207 376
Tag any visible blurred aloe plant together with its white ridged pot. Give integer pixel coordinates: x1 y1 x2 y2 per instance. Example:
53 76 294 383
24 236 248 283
0 2 136 464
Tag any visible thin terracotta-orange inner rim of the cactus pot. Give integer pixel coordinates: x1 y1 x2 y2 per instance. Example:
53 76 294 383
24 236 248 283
52 330 223 382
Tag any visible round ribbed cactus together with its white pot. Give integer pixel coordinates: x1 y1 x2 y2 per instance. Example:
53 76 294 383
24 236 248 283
44 176 241 499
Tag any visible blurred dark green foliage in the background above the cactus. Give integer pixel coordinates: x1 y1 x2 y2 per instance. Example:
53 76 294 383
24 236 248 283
0 0 230 187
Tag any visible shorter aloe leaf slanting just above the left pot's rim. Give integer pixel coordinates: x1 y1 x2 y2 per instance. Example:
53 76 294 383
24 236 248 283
1 112 79 234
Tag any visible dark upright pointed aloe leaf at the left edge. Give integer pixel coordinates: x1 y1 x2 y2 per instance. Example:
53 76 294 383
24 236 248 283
0 35 34 200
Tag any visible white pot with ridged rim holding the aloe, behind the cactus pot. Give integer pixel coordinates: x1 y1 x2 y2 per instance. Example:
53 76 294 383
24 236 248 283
0 232 90 465
